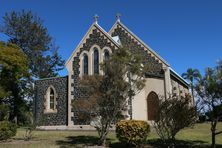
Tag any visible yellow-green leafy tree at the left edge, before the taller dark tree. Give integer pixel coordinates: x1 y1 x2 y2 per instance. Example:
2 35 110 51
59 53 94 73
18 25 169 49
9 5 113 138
0 42 29 123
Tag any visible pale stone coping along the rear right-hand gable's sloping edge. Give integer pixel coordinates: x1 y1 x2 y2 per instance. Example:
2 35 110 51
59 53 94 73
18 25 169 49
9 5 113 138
109 20 170 66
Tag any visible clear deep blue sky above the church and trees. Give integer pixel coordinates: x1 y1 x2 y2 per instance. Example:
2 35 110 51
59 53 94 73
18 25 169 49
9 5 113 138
0 0 222 75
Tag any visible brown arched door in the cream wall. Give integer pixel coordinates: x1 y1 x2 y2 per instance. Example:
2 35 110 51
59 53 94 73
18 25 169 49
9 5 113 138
147 91 159 120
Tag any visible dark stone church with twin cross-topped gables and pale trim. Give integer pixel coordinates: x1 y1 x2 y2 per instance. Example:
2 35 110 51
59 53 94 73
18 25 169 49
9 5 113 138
33 15 189 130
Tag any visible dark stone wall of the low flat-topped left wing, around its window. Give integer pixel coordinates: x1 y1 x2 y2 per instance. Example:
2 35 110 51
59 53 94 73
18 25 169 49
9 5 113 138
34 76 68 126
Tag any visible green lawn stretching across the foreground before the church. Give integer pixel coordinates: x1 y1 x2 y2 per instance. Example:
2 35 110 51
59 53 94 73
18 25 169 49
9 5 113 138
0 123 222 148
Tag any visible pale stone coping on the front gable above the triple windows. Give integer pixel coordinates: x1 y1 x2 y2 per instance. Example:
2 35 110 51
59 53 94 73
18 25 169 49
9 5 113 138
65 22 120 66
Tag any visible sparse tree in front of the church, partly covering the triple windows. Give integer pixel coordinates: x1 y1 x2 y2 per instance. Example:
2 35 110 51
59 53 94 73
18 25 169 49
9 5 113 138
73 48 148 145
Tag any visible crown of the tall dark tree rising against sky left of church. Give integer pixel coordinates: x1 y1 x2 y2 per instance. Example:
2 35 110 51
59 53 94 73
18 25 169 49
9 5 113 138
1 10 64 78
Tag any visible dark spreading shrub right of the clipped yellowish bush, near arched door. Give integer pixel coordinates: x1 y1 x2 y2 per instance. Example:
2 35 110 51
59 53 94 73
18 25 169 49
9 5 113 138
154 95 196 141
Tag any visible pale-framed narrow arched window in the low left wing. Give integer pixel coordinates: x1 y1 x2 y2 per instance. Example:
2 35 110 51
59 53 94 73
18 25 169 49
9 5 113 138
44 86 57 113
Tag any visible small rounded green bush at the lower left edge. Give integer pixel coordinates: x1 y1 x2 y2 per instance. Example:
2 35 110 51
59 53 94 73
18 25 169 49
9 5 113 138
0 121 17 140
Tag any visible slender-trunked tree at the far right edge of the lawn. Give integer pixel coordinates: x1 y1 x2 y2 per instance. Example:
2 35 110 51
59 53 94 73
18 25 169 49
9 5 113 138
196 61 222 147
